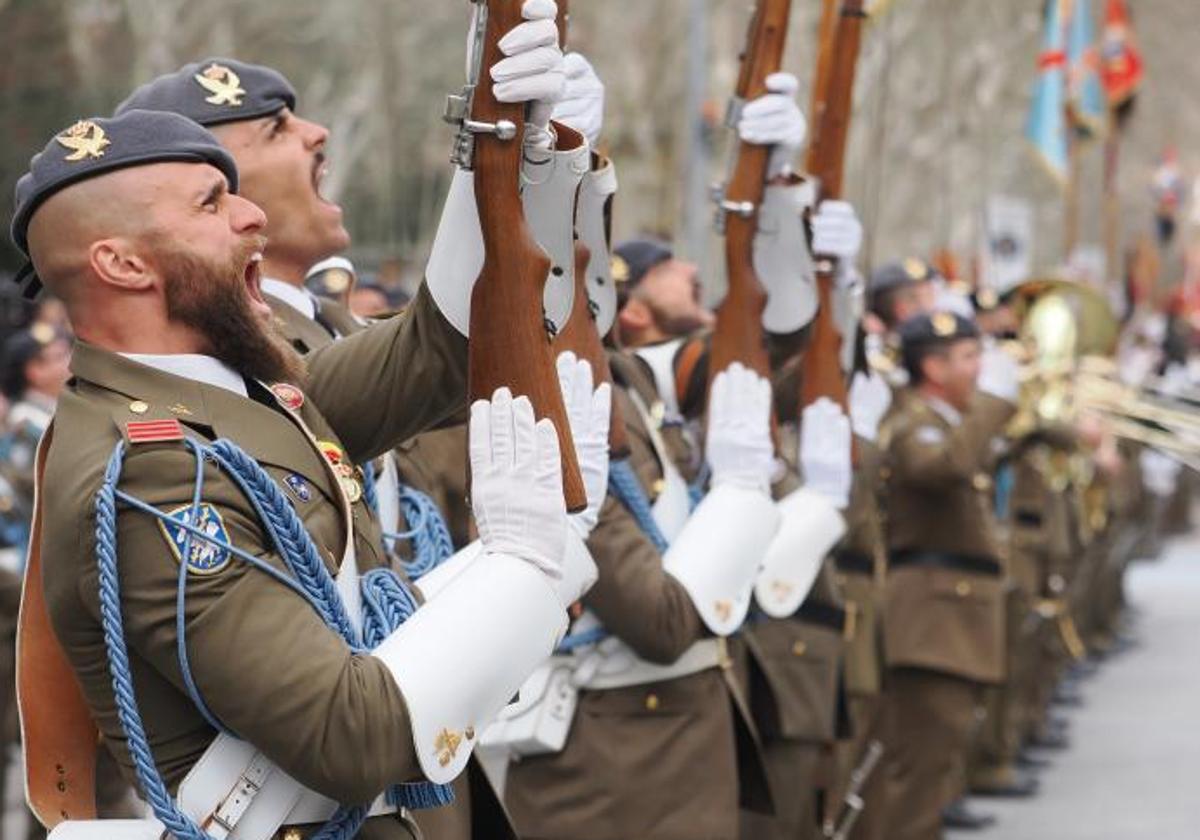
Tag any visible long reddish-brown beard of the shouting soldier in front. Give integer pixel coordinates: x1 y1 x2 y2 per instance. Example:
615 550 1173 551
156 242 304 384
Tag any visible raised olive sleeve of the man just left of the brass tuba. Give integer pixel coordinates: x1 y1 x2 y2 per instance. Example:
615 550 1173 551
889 400 1016 486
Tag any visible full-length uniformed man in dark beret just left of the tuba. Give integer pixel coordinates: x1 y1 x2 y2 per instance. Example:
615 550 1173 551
881 312 1016 840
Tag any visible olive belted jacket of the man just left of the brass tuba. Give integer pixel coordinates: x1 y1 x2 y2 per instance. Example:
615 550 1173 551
880 388 1015 683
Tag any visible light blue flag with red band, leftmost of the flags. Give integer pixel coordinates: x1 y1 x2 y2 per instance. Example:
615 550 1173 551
1025 0 1069 184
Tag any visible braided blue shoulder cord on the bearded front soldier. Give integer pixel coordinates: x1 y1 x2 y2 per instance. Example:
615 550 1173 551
96 438 454 840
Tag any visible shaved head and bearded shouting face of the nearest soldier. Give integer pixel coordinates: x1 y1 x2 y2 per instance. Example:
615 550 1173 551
28 162 299 382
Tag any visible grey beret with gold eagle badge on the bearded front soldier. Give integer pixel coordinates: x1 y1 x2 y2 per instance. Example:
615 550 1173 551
10 110 238 296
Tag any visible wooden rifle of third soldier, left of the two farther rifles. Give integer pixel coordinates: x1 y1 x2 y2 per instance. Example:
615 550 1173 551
708 0 792 388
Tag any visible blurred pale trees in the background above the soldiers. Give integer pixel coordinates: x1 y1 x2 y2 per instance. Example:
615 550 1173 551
0 0 1200 292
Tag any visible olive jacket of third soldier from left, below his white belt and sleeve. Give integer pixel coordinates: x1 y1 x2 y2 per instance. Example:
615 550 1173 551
505 354 768 840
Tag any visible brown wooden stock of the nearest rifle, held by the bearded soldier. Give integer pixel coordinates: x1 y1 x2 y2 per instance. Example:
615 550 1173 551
468 0 587 511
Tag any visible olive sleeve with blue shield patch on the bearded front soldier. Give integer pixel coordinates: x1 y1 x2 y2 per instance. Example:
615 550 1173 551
109 449 420 803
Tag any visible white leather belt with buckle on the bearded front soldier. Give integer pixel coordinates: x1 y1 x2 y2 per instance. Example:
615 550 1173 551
178 734 400 840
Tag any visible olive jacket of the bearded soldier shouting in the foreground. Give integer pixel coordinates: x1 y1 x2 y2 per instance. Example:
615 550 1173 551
41 290 466 840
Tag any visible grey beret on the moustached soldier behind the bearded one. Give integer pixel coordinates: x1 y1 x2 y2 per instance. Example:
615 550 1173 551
116 59 296 126
